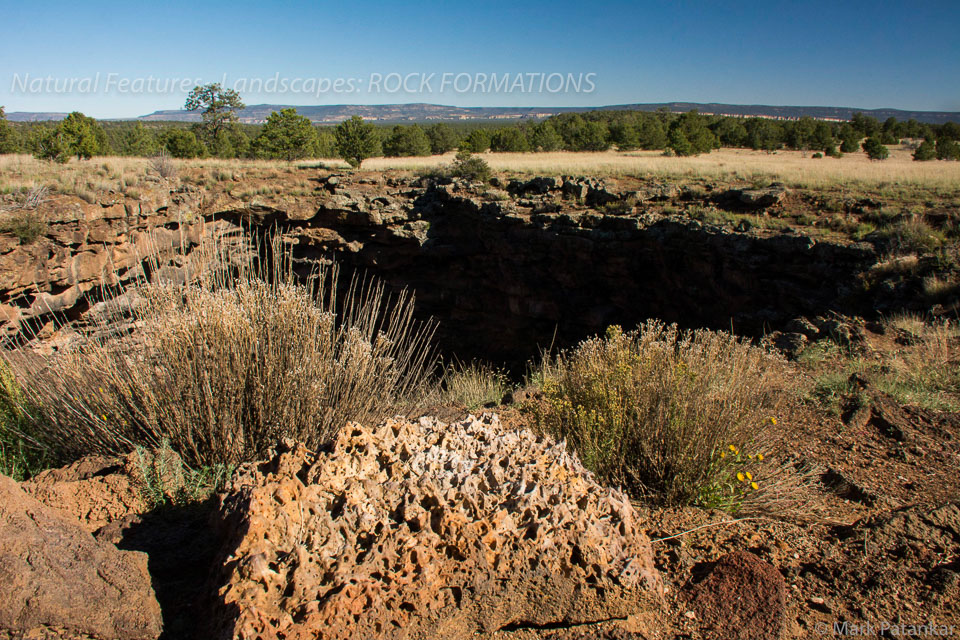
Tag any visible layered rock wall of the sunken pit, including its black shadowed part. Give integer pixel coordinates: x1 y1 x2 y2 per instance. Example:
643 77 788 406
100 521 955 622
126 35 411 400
0 174 876 365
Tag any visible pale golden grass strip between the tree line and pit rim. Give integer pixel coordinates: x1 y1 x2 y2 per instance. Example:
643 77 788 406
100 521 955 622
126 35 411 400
0 147 960 198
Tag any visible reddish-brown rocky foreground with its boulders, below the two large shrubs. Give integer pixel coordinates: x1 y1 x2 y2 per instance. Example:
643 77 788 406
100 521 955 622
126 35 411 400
0 344 960 640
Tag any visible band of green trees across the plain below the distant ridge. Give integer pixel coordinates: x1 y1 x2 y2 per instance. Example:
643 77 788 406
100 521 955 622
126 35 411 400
0 84 960 166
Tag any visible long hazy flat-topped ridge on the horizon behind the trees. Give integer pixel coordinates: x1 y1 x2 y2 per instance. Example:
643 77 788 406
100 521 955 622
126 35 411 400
7 102 960 124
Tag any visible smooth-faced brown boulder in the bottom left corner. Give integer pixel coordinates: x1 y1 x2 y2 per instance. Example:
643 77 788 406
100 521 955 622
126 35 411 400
0 476 162 640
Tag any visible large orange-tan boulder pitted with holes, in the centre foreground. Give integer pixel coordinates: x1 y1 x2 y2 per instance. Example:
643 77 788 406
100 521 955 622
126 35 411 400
215 415 662 640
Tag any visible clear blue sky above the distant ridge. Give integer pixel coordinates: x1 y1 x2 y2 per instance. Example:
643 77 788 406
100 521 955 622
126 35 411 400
0 0 960 118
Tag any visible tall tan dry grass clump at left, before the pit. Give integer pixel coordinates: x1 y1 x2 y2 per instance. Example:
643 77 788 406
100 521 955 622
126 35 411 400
4 230 432 466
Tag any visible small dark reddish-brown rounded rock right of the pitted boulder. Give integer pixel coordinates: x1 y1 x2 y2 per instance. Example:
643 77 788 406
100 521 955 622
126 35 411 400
690 551 787 640
